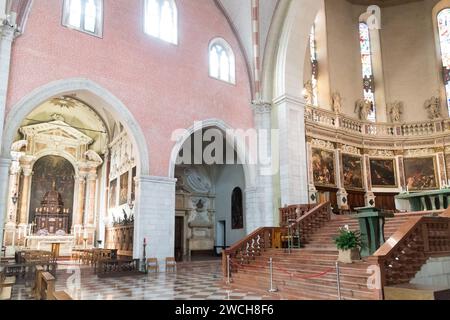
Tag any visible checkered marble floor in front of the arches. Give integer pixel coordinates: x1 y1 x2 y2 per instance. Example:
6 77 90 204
12 262 273 300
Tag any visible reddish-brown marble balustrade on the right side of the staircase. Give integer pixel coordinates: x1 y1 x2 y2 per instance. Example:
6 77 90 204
369 210 450 297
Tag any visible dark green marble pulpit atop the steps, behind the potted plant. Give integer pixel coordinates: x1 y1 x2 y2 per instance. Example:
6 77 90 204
354 207 394 257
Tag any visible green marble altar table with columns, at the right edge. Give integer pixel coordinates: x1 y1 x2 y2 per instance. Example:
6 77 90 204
395 189 450 212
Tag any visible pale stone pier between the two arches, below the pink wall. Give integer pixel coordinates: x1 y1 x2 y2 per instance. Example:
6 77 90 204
133 176 176 272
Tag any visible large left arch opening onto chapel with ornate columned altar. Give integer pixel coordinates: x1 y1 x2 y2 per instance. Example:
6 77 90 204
2 79 149 256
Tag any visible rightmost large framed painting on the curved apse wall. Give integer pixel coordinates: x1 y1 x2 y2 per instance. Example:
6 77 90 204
403 157 438 191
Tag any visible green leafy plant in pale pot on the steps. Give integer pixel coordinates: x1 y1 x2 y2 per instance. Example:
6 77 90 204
334 226 362 263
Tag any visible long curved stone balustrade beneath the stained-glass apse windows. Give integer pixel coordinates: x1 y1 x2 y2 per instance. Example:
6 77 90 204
305 106 450 137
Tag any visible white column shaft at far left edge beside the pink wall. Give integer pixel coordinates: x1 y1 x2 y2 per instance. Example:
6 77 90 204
0 21 15 150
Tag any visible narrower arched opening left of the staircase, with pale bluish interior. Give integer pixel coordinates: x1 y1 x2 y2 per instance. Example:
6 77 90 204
171 121 255 261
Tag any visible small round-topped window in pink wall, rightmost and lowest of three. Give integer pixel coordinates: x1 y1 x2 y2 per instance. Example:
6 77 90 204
209 38 236 83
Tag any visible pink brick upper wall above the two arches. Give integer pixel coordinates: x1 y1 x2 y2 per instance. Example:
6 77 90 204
7 0 253 176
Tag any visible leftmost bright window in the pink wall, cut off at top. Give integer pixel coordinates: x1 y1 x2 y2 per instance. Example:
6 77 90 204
63 0 103 37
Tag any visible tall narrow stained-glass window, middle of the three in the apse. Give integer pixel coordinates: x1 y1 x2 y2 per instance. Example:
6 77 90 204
359 22 376 122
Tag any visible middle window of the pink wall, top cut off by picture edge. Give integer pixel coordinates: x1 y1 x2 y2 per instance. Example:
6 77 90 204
144 0 178 44
